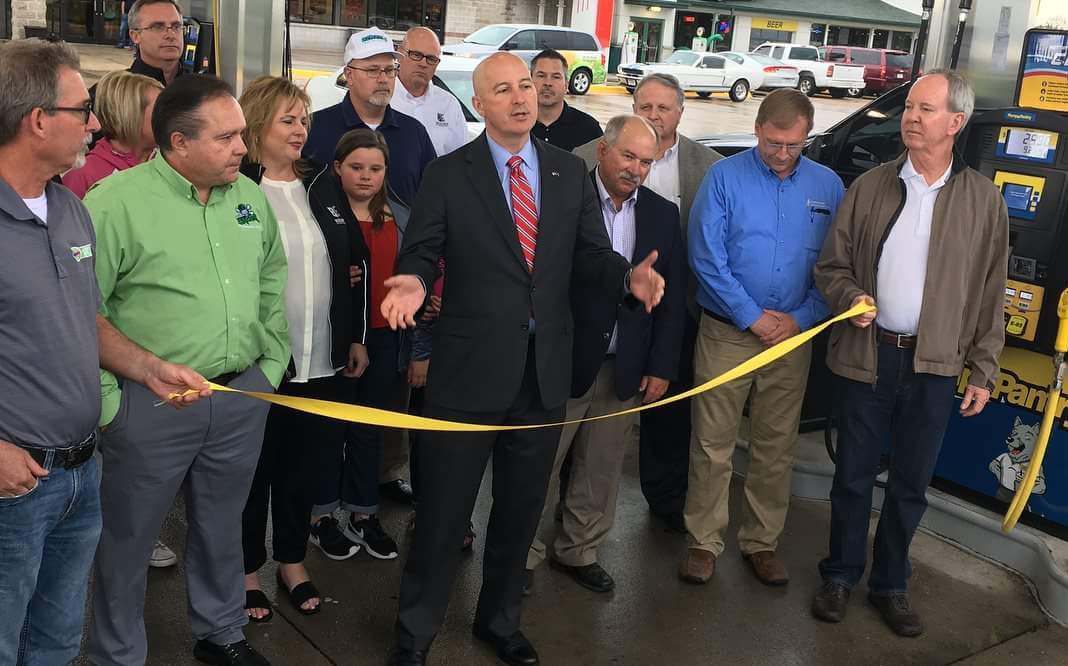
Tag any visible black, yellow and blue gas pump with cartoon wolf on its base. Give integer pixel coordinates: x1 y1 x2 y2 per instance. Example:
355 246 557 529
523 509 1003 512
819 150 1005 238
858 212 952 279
936 30 1068 538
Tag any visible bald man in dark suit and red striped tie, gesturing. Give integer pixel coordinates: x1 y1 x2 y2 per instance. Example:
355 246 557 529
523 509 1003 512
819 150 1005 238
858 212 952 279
382 52 664 665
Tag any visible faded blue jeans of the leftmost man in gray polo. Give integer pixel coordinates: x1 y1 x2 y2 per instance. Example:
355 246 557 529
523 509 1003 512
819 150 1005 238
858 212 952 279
0 458 100 666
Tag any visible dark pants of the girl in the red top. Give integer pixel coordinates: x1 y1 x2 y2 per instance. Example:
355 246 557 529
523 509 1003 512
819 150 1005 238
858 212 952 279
312 328 403 516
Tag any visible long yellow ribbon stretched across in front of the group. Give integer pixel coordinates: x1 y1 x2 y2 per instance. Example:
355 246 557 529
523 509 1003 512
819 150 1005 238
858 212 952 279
200 303 875 432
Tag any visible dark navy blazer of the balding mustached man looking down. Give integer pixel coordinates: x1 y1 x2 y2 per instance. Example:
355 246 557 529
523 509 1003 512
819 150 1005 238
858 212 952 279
571 172 687 400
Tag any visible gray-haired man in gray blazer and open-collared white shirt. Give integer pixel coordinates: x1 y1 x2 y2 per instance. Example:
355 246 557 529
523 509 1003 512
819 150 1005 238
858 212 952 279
575 74 723 533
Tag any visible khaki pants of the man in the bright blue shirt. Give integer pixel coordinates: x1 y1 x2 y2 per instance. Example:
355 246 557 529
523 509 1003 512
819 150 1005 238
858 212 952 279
684 315 812 557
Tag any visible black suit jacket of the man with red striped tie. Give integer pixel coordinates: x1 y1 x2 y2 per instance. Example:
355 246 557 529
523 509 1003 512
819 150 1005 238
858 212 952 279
396 133 630 413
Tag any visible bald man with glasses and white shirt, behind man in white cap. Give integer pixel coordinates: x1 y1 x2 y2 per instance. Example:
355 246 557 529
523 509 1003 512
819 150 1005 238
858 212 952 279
390 27 468 155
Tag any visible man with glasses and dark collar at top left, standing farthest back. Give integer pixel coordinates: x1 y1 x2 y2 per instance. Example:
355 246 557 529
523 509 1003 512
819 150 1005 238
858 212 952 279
129 0 184 85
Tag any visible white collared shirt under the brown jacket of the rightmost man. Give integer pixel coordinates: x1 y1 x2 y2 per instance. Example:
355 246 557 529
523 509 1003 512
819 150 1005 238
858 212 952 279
876 157 953 335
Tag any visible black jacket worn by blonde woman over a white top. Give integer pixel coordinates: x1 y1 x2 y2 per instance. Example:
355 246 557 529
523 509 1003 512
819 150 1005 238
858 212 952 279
241 162 378 378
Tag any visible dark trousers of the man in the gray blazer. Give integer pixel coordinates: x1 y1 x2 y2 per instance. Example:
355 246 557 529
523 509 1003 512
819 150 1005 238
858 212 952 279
638 315 697 523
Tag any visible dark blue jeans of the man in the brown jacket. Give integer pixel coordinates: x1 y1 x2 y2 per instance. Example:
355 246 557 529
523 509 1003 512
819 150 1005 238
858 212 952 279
819 345 957 594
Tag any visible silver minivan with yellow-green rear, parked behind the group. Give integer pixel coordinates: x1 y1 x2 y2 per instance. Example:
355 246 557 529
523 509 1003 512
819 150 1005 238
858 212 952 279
442 23 608 95
